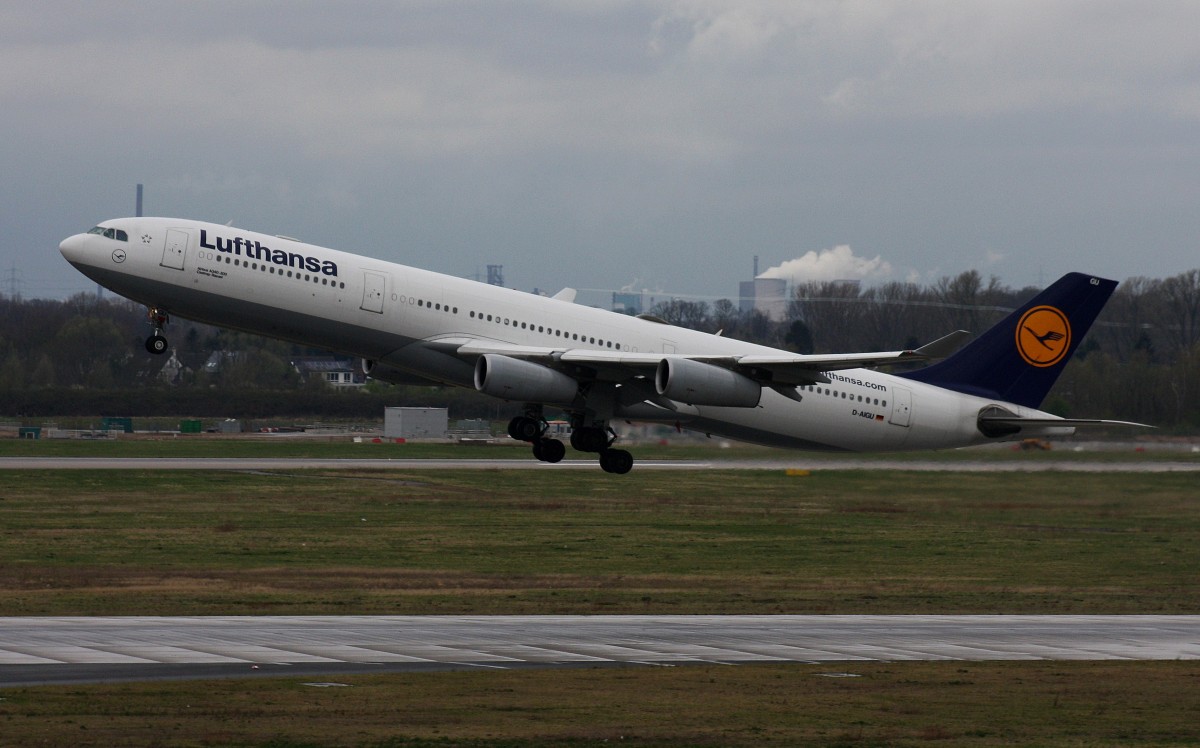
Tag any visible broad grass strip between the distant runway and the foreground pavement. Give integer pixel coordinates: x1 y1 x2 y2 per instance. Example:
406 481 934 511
0 471 1200 616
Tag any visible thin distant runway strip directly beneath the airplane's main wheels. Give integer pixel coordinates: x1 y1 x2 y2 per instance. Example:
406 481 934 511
0 456 1200 473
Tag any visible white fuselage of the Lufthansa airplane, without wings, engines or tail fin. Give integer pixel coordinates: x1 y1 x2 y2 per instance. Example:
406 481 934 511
61 217 1069 451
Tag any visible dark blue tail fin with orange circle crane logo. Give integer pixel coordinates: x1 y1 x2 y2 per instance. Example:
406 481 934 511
900 273 1117 408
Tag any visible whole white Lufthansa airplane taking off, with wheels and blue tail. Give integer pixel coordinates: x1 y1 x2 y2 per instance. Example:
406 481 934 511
60 217 1142 473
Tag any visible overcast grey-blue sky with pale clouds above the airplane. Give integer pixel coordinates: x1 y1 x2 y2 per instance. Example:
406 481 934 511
0 0 1200 298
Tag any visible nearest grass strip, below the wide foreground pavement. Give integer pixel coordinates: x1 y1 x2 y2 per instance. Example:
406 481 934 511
0 662 1200 747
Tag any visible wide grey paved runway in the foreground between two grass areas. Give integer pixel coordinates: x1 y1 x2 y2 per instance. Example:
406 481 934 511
0 616 1200 688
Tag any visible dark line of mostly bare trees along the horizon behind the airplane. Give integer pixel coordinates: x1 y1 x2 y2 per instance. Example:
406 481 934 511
0 270 1200 431
